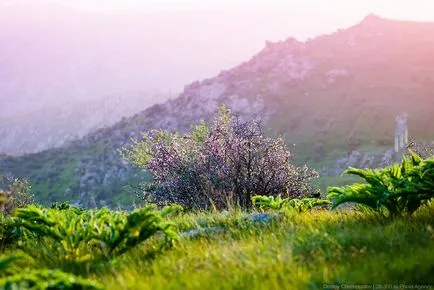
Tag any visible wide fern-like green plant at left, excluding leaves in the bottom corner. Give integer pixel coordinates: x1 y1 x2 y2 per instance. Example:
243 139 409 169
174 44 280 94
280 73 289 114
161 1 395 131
14 206 177 262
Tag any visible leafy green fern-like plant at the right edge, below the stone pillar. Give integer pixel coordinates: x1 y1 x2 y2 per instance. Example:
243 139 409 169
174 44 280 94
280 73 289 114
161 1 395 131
328 151 434 216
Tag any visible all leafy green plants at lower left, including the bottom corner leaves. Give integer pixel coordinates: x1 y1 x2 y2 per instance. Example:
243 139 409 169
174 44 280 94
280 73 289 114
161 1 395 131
0 203 182 290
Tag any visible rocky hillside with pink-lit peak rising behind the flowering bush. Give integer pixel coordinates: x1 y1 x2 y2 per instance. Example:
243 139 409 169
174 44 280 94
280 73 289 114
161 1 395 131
0 15 434 205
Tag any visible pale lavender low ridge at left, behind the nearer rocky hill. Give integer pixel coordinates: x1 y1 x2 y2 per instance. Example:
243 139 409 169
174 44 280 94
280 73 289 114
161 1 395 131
0 92 173 155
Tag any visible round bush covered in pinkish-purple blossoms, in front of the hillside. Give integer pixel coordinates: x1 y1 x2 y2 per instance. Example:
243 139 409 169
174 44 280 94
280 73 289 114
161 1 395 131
121 107 318 208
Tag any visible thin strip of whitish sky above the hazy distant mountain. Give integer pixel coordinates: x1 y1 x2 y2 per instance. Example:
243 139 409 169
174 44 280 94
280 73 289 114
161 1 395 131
52 0 434 20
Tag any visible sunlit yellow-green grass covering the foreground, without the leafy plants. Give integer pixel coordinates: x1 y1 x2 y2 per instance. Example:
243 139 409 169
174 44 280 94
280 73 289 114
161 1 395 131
6 205 428 289
